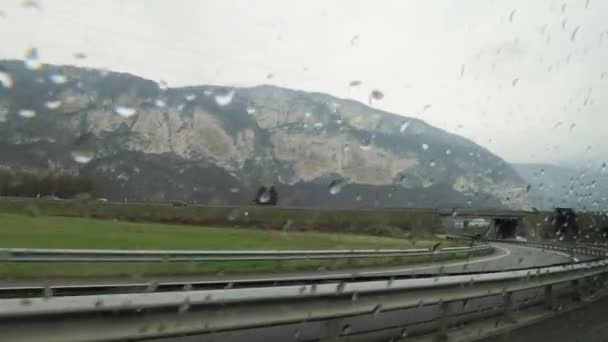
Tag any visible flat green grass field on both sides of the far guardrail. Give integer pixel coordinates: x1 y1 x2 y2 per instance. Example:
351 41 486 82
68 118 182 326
0 213 466 278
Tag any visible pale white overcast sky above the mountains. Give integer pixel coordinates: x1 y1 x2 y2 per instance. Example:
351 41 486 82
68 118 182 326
0 0 608 167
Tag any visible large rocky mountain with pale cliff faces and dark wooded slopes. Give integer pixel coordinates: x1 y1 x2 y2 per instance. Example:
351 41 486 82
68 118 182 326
0 61 527 208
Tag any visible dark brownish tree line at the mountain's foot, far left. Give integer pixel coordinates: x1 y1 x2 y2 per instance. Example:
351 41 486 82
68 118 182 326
0 171 94 198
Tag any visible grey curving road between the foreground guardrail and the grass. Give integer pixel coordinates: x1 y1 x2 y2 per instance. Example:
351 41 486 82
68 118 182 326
0 243 587 287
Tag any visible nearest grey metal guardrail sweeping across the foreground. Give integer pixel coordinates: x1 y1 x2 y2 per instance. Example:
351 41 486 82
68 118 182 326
0 242 608 341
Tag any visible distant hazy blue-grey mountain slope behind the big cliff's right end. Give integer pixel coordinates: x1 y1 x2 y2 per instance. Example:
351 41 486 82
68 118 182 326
513 164 608 210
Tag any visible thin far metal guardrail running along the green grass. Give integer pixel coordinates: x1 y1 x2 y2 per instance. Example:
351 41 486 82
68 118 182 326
0 245 492 262
